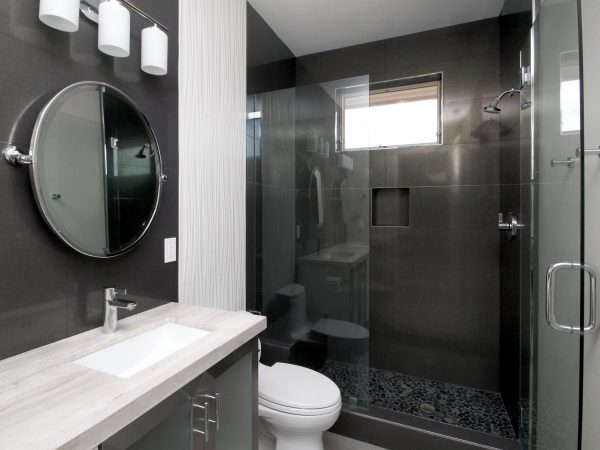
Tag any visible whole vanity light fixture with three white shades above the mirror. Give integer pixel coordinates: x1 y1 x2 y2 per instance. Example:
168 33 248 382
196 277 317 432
39 0 169 75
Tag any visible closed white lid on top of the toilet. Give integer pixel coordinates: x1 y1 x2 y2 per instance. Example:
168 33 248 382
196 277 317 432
258 363 341 409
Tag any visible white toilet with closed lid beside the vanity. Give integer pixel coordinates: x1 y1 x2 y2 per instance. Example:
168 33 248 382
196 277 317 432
258 347 342 450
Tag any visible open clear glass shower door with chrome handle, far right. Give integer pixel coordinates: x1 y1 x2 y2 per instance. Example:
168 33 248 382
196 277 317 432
523 0 590 450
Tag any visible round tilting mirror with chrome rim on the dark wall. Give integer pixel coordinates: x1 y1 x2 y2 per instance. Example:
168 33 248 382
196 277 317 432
30 82 162 258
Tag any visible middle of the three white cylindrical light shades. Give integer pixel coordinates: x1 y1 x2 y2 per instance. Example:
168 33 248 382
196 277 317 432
98 0 131 58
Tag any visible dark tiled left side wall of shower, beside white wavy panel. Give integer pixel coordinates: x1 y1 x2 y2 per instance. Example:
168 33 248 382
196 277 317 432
246 4 296 311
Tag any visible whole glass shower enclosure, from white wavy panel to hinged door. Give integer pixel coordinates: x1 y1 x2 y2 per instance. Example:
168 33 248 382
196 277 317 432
246 0 596 450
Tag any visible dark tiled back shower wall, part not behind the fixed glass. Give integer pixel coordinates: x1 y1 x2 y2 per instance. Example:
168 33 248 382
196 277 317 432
296 19 510 390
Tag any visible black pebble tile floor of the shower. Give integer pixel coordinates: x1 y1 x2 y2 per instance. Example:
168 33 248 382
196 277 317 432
321 360 515 439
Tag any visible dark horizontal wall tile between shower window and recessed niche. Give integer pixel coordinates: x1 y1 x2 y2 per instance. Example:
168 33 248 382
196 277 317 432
384 141 499 187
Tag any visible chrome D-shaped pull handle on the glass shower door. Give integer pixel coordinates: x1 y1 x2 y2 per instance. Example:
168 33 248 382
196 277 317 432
546 262 598 334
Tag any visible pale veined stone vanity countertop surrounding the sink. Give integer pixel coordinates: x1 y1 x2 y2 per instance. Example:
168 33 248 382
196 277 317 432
0 303 266 450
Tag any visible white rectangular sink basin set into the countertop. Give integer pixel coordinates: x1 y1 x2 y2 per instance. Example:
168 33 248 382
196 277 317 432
74 323 210 378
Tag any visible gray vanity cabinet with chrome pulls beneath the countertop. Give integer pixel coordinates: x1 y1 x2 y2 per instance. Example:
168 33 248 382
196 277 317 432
101 339 258 450
